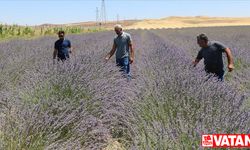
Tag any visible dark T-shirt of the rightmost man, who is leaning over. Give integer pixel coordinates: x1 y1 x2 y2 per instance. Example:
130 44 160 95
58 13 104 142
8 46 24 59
196 41 227 73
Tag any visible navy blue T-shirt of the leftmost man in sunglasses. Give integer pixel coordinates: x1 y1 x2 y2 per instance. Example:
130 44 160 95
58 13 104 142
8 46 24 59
55 39 71 59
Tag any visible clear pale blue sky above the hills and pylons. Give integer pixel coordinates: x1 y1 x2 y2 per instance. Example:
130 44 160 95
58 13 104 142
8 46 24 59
0 0 250 25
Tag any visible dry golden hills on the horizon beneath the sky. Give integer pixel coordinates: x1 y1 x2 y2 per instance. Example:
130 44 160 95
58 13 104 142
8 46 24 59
61 16 250 29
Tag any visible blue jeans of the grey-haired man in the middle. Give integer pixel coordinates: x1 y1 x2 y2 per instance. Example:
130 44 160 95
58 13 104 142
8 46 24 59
116 57 131 79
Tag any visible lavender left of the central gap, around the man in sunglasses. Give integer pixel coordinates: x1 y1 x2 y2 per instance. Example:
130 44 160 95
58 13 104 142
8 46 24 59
0 32 133 150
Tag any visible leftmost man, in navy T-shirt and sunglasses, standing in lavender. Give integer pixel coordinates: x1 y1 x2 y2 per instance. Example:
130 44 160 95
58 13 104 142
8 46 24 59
53 31 72 61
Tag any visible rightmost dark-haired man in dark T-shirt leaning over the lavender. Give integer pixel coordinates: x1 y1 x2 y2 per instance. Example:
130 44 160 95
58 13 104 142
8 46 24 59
193 34 234 80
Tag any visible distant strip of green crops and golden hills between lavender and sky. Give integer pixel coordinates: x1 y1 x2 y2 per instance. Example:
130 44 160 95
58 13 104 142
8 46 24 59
0 16 250 40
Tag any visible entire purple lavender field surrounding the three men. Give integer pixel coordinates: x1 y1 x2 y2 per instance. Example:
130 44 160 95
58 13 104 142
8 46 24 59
0 27 250 150
